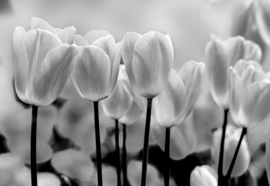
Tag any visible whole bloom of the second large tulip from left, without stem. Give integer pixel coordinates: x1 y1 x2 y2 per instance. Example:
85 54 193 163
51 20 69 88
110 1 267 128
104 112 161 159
71 31 121 101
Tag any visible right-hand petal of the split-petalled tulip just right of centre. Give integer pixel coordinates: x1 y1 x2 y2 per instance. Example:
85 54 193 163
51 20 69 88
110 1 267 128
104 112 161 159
178 61 205 122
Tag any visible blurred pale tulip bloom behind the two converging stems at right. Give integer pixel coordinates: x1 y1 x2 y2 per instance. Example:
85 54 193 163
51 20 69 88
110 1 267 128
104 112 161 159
212 125 250 177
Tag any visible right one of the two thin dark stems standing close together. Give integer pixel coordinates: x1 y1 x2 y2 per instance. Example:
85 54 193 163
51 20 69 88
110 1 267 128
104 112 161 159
122 124 129 186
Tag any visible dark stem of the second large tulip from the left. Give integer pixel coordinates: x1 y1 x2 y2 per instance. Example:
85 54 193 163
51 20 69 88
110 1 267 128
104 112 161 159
93 101 103 186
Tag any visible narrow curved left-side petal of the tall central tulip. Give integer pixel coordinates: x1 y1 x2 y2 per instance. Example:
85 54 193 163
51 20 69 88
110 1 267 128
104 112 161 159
122 32 141 93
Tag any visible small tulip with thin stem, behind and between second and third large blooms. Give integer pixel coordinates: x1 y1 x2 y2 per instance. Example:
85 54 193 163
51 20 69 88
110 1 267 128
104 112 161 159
102 65 132 186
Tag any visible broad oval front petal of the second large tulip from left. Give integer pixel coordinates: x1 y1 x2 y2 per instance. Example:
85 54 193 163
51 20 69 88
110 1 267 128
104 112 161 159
71 46 110 101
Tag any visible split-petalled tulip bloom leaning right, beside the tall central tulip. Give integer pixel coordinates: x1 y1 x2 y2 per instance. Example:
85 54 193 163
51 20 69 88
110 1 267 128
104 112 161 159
152 61 204 127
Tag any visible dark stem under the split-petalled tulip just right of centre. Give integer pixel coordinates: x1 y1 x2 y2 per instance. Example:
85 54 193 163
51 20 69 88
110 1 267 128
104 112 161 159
164 127 171 186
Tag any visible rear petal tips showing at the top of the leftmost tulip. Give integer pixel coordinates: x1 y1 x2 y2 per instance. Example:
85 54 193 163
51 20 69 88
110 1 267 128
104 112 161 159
31 17 76 45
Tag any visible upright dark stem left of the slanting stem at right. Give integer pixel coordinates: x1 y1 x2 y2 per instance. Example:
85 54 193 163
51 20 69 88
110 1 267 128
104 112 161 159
218 109 229 182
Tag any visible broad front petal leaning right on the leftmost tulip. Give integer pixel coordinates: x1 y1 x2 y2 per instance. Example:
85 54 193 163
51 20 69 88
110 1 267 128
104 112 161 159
33 44 78 106
